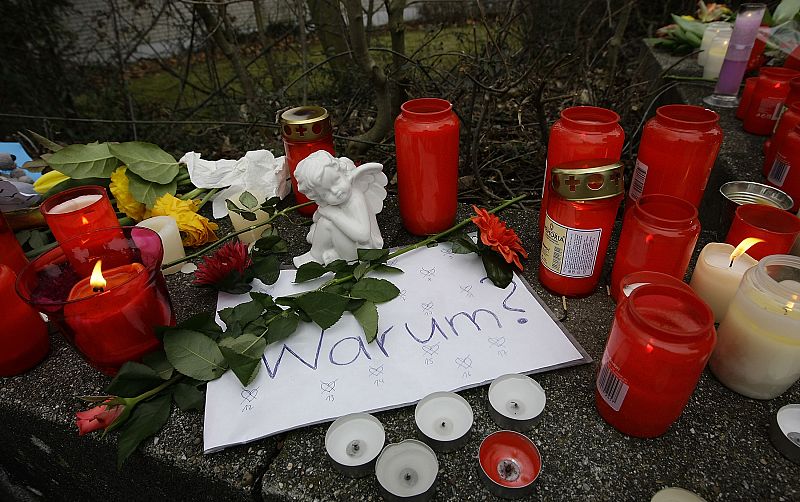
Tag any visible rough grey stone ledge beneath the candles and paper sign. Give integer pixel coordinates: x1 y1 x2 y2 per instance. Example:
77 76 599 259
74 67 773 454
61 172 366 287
0 44 800 501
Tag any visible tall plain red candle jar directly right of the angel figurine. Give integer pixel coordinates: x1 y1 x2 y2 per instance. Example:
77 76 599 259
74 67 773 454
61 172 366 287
394 98 460 235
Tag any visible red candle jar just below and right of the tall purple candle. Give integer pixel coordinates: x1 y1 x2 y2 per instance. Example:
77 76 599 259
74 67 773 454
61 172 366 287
743 67 798 136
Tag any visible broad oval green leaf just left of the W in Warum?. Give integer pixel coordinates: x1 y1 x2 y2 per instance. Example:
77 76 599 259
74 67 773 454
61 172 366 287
164 329 227 381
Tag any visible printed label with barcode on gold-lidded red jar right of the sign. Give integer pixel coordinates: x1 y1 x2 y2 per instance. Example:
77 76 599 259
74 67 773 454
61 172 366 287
542 214 603 277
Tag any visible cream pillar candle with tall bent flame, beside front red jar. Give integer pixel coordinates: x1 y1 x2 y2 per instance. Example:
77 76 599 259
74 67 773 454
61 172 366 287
689 237 762 322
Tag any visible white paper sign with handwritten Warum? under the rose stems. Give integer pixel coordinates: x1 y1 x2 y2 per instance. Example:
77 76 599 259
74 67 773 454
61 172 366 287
203 245 591 453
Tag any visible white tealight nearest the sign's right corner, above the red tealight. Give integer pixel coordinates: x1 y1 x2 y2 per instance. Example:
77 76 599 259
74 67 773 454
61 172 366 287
489 373 547 431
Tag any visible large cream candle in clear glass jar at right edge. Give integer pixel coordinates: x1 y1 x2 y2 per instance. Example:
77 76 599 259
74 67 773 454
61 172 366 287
709 255 800 399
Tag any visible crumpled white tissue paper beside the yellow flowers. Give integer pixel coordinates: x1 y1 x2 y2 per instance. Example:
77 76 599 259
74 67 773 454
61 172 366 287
180 150 292 219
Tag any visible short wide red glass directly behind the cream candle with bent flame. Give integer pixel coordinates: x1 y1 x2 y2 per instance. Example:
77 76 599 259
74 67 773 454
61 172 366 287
725 204 800 260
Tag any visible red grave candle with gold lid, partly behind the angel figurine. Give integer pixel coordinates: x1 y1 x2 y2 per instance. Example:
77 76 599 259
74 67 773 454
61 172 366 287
280 106 336 216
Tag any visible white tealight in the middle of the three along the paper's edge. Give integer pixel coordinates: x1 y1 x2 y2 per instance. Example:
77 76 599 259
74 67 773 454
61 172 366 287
414 392 473 452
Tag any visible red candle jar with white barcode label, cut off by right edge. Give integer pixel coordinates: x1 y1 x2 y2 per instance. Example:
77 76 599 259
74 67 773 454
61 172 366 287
764 124 800 212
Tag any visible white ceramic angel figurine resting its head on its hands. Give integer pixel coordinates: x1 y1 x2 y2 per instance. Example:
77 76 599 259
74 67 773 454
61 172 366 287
293 150 388 267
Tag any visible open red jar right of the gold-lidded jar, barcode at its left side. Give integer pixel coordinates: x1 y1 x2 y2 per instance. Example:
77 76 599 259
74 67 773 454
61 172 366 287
628 105 722 207
